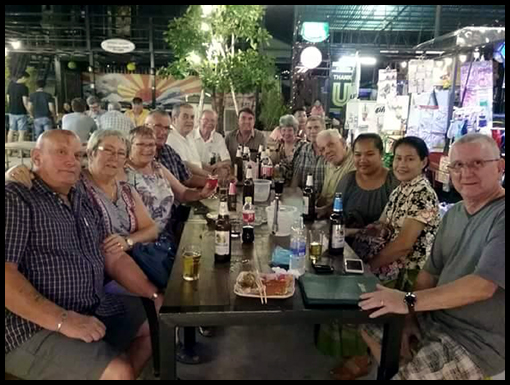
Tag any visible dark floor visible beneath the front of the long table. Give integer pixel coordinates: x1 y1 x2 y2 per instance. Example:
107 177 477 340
140 325 375 380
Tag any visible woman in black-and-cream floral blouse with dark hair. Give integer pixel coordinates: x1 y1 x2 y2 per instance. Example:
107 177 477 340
368 136 440 290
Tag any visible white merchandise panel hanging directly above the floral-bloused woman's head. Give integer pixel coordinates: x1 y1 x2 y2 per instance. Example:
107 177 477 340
407 91 449 150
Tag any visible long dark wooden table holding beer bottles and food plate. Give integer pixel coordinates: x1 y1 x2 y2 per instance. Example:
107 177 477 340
160 189 404 380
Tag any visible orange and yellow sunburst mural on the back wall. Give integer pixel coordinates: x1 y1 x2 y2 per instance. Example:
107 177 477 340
82 73 202 106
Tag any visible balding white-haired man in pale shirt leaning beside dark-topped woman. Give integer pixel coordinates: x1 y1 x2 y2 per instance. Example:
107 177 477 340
317 130 355 215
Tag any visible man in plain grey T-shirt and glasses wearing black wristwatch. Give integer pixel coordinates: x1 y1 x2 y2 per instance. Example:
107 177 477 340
350 134 505 380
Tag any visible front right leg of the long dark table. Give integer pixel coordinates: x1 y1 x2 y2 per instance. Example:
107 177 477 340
377 317 405 381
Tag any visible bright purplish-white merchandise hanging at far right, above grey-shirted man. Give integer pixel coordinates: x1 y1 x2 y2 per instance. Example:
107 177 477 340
460 61 493 135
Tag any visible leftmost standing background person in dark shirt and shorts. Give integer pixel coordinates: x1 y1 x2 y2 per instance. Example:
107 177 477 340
7 72 30 143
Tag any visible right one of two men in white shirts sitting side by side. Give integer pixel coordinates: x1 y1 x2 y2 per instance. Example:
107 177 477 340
193 110 231 172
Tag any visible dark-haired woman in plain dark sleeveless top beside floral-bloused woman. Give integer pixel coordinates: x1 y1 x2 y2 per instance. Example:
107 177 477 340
337 134 400 231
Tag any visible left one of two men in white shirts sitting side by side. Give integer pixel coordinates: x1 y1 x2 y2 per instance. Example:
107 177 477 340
167 104 209 177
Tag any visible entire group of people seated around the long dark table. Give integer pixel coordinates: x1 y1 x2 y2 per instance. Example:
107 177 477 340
5 100 505 379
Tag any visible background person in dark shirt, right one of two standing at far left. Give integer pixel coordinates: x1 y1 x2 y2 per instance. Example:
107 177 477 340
28 80 57 140
